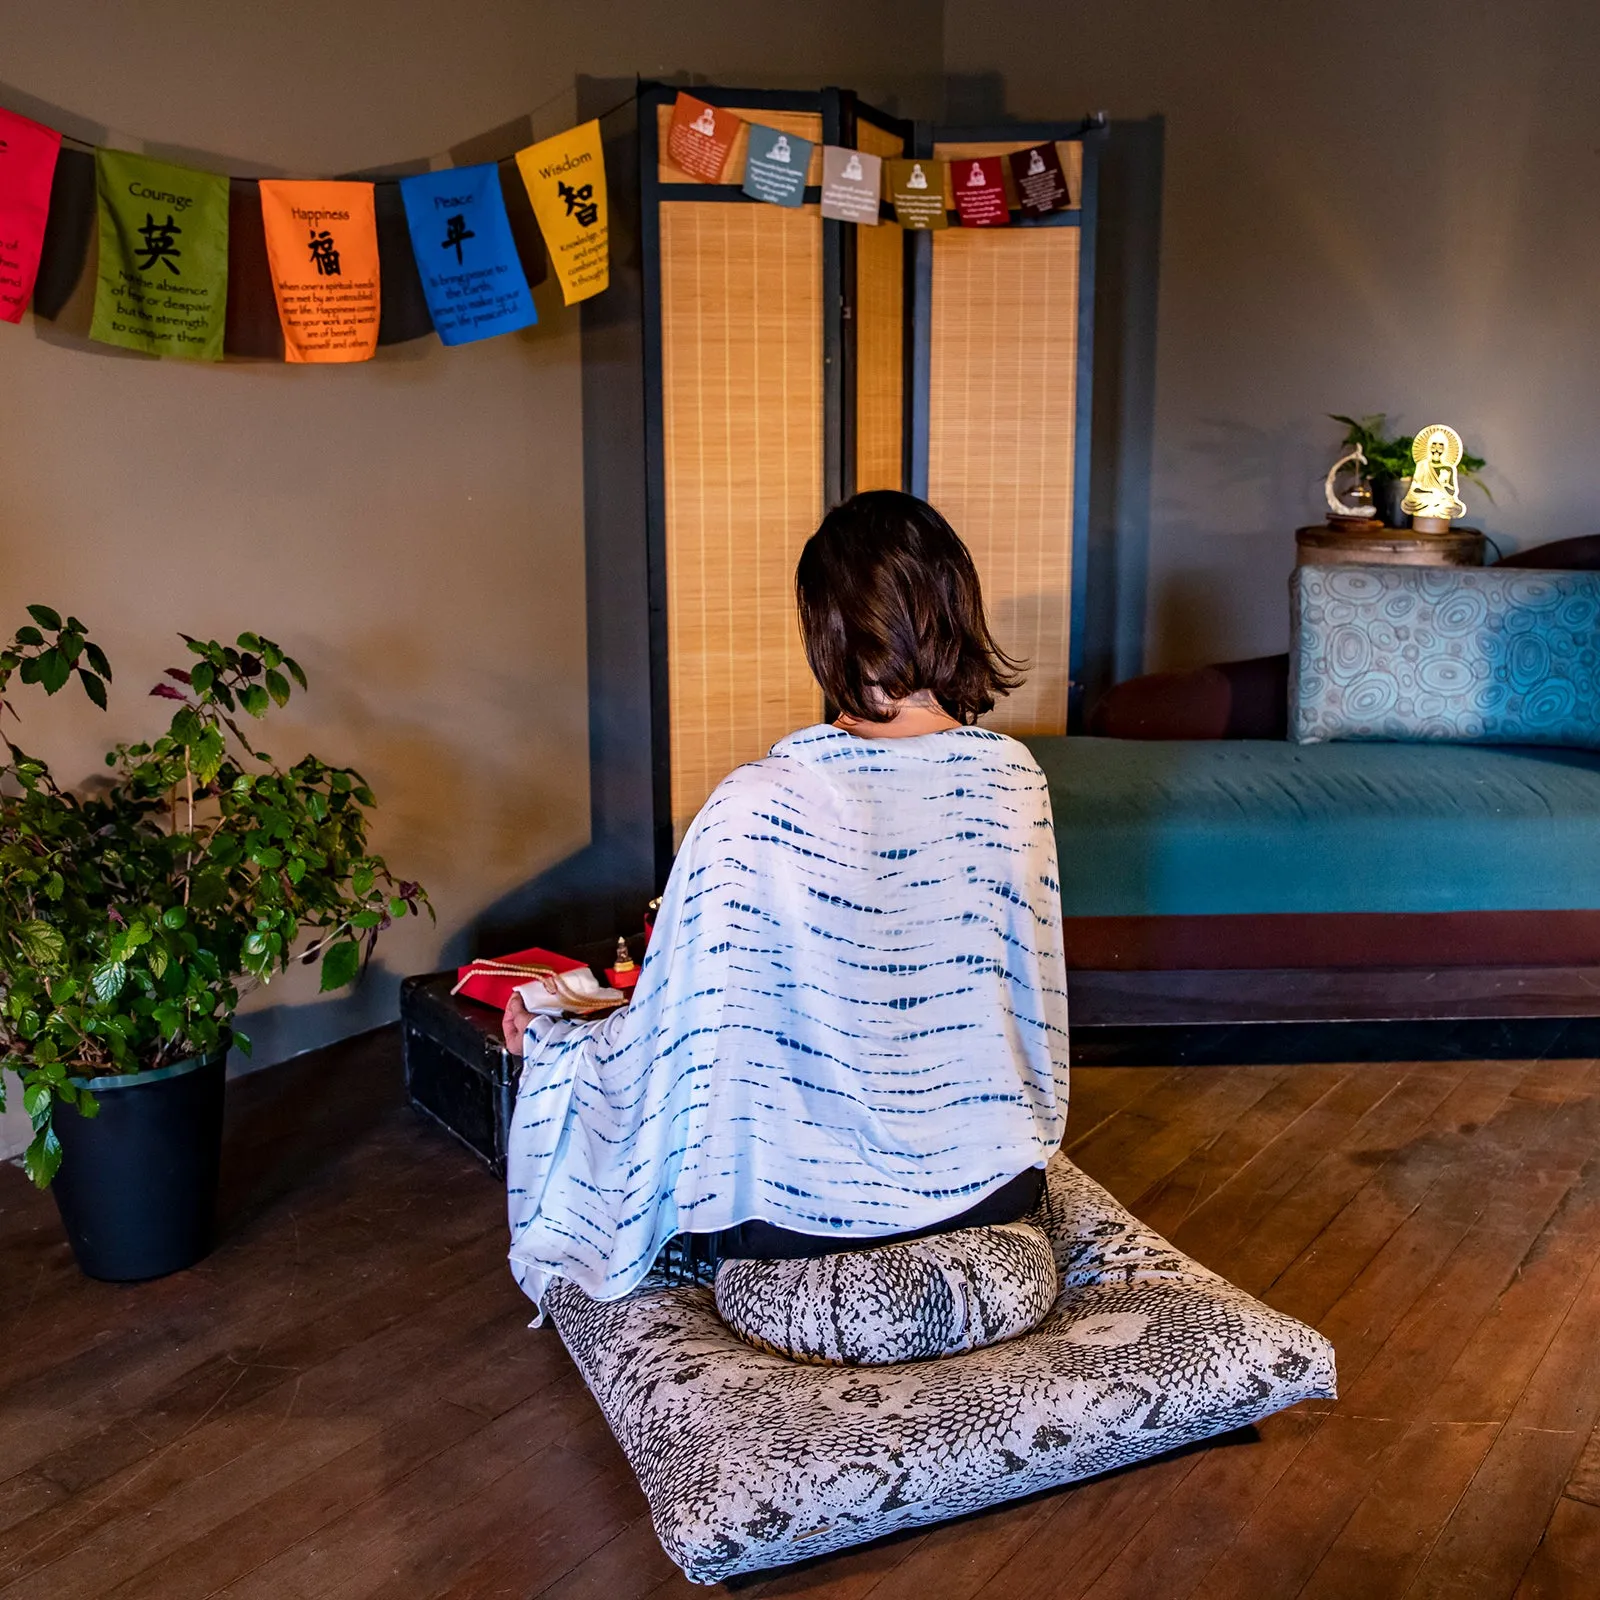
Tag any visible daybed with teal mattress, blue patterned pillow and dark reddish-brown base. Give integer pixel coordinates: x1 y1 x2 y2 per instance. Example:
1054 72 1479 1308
1029 541 1600 1059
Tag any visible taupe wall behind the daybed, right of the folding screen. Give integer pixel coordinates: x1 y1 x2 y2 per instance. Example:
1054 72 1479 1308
946 0 1600 666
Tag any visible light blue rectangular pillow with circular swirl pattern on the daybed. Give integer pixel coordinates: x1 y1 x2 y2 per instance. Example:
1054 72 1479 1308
1290 566 1600 749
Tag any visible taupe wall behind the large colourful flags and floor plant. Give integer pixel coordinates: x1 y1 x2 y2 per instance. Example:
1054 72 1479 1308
0 0 939 1081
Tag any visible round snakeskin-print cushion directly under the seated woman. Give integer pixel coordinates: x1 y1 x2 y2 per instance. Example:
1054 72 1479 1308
717 1222 1059 1366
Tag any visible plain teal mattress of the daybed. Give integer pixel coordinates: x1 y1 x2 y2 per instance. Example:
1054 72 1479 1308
1027 738 1600 917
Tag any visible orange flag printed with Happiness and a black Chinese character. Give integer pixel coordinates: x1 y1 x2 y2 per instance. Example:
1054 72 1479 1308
261 178 378 362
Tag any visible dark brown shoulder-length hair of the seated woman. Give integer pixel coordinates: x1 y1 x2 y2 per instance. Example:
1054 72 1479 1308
795 490 1022 722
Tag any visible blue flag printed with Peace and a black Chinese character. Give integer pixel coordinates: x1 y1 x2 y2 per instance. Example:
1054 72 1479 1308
400 162 539 344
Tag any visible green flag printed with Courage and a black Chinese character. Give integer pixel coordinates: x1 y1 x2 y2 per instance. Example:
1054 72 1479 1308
90 150 227 362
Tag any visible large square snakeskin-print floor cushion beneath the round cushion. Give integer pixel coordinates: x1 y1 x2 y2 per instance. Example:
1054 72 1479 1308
544 1154 1334 1584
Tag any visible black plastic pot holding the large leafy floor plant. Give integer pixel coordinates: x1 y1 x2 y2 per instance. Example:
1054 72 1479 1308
50 1048 227 1283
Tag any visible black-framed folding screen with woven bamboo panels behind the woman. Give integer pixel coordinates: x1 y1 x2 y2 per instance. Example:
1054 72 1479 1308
640 88 1088 872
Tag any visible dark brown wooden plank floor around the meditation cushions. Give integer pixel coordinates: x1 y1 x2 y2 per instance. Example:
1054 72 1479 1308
0 1035 1600 1600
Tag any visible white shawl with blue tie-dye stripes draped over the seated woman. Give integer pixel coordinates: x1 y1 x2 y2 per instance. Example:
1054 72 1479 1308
507 726 1067 1302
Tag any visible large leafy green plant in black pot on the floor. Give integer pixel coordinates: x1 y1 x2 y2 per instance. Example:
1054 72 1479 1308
0 605 432 1280
